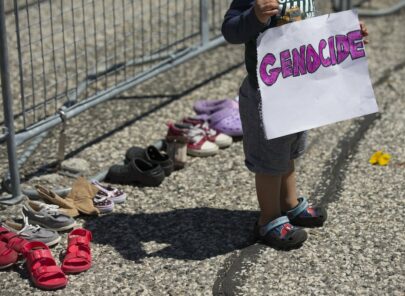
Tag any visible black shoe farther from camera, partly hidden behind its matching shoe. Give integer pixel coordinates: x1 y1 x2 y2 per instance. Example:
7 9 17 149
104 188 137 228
125 145 174 176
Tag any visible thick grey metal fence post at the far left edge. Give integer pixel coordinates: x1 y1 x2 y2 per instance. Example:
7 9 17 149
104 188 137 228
0 1 22 204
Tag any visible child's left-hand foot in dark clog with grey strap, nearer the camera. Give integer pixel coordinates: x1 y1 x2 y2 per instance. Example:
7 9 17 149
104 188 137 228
254 216 307 250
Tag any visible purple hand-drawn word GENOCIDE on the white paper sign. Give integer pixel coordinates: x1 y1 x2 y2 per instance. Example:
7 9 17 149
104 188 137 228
259 30 366 86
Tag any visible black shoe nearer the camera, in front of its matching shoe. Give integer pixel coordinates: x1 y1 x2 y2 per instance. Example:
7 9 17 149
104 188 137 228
106 158 165 186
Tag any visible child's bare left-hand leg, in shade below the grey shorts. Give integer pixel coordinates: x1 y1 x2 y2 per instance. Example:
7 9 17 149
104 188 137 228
256 174 281 225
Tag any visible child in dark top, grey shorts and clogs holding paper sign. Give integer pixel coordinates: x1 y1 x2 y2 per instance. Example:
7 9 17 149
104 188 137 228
222 0 367 249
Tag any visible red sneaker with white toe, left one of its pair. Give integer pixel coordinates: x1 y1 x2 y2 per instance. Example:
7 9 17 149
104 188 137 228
166 123 219 157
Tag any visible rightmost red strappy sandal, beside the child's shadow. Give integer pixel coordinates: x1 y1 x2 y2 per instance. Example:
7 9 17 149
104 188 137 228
62 228 92 273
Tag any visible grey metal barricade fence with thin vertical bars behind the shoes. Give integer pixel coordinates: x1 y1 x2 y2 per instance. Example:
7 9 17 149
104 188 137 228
0 0 404 203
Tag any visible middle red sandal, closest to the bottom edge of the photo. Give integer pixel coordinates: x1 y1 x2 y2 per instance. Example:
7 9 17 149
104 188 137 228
22 242 67 290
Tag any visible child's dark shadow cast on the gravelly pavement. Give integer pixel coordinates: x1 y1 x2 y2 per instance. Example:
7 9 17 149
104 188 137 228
84 208 257 261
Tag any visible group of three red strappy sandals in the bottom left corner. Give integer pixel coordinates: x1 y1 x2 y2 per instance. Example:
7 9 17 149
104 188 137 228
0 226 92 290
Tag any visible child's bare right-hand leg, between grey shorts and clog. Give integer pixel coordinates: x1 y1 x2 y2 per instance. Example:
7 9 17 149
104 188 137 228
280 160 298 212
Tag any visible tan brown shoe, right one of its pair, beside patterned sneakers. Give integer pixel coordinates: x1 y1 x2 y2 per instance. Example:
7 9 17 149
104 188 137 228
66 177 100 215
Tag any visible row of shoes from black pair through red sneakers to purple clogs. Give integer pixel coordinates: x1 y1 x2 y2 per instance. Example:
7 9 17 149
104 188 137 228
105 99 242 186
